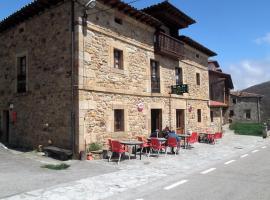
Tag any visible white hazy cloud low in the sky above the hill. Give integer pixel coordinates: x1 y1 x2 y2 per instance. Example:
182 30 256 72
225 59 270 90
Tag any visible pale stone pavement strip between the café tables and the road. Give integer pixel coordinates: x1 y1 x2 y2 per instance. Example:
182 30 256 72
2 126 270 200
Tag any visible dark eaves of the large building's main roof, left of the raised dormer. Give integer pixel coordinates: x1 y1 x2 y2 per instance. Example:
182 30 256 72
0 0 162 33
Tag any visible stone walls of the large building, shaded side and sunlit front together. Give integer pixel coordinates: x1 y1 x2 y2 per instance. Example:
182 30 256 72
0 1 215 153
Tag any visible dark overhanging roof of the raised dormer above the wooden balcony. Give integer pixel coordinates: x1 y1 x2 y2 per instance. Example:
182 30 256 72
142 1 196 29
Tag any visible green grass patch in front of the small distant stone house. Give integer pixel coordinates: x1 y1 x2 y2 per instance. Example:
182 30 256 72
230 122 264 136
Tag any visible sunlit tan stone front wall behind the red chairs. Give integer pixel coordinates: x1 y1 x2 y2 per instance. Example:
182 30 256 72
77 4 210 150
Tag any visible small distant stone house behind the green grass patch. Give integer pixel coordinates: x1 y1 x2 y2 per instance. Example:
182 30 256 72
229 91 263 123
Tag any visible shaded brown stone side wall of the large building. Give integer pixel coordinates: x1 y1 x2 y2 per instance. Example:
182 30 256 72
0 3 72 148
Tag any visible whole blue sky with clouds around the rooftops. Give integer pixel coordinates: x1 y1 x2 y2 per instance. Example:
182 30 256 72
0 0 270 90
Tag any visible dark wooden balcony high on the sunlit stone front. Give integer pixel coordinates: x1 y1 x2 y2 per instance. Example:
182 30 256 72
155 32 184 58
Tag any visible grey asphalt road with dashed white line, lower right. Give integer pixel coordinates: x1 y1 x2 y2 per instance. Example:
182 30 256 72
114 146 270 200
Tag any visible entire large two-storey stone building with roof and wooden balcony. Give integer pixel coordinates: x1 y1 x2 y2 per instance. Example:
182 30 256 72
0 0 216 155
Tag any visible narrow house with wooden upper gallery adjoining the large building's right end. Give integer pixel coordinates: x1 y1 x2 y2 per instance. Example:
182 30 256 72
208 61 234 132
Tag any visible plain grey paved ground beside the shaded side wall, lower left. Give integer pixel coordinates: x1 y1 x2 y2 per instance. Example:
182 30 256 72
0 146 116 199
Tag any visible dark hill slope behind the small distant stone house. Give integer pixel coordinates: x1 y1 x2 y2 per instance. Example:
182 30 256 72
243 81 270 121
